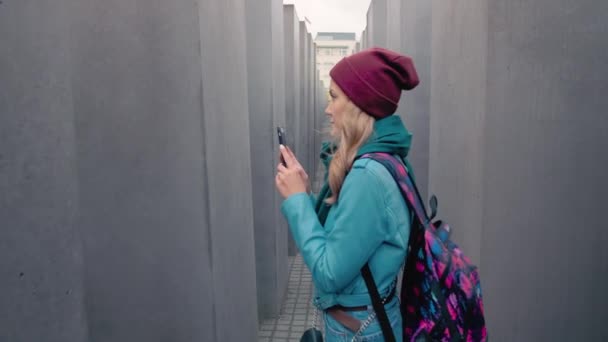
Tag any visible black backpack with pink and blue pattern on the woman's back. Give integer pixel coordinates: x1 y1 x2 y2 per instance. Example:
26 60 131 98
361 153 488 342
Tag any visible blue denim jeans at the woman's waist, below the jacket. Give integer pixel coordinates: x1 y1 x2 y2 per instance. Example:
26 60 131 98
323 296 403 342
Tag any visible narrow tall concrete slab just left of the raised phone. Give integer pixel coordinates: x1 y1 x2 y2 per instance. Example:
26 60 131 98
246 0 288 319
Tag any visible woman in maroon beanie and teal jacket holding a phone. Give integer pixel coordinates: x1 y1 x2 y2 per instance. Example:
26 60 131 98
276 48 418 342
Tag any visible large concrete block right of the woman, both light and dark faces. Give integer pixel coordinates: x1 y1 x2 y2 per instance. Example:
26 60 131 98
430 1 608 341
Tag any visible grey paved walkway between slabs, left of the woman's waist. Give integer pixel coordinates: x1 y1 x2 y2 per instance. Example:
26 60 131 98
258 254 323 342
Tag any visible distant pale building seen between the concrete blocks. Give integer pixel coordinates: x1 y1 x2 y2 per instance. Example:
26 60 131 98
315 32 357 88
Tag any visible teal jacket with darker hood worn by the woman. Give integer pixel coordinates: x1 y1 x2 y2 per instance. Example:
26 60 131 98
281 116 411 309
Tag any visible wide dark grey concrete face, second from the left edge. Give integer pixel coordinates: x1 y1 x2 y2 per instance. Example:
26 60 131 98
71 0 218 341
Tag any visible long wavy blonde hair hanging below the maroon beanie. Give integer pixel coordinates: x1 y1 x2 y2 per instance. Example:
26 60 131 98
325 101 375 204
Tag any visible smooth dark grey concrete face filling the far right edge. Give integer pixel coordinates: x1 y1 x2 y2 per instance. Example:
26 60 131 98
481 0 608 341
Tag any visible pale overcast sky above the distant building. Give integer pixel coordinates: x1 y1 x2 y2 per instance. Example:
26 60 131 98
283 0 371 39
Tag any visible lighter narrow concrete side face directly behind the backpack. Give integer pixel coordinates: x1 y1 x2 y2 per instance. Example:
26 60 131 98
429 2 487 262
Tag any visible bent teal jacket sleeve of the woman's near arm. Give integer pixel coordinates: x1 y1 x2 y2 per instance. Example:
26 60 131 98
281 168 388 293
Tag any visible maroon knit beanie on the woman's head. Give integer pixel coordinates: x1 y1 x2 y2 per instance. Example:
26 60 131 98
329 48 420 119
